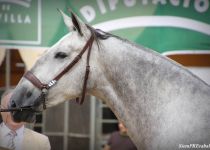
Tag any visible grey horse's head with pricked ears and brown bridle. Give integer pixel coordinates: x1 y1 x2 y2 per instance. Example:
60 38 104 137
9 11 94 122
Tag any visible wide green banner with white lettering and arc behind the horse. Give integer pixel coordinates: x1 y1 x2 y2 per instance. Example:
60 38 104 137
0 0 210 53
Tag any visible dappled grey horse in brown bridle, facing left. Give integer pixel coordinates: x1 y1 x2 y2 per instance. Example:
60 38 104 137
8 11 210 150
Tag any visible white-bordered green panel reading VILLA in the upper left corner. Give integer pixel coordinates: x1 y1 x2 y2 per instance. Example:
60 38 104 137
0 0 41 44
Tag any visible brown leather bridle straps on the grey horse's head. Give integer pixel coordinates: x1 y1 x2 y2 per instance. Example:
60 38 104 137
24 34 94 109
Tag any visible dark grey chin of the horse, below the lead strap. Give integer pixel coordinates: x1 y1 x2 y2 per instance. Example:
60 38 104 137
12 111 36 123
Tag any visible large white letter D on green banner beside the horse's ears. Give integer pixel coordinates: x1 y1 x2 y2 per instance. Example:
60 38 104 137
80 5 96 22
